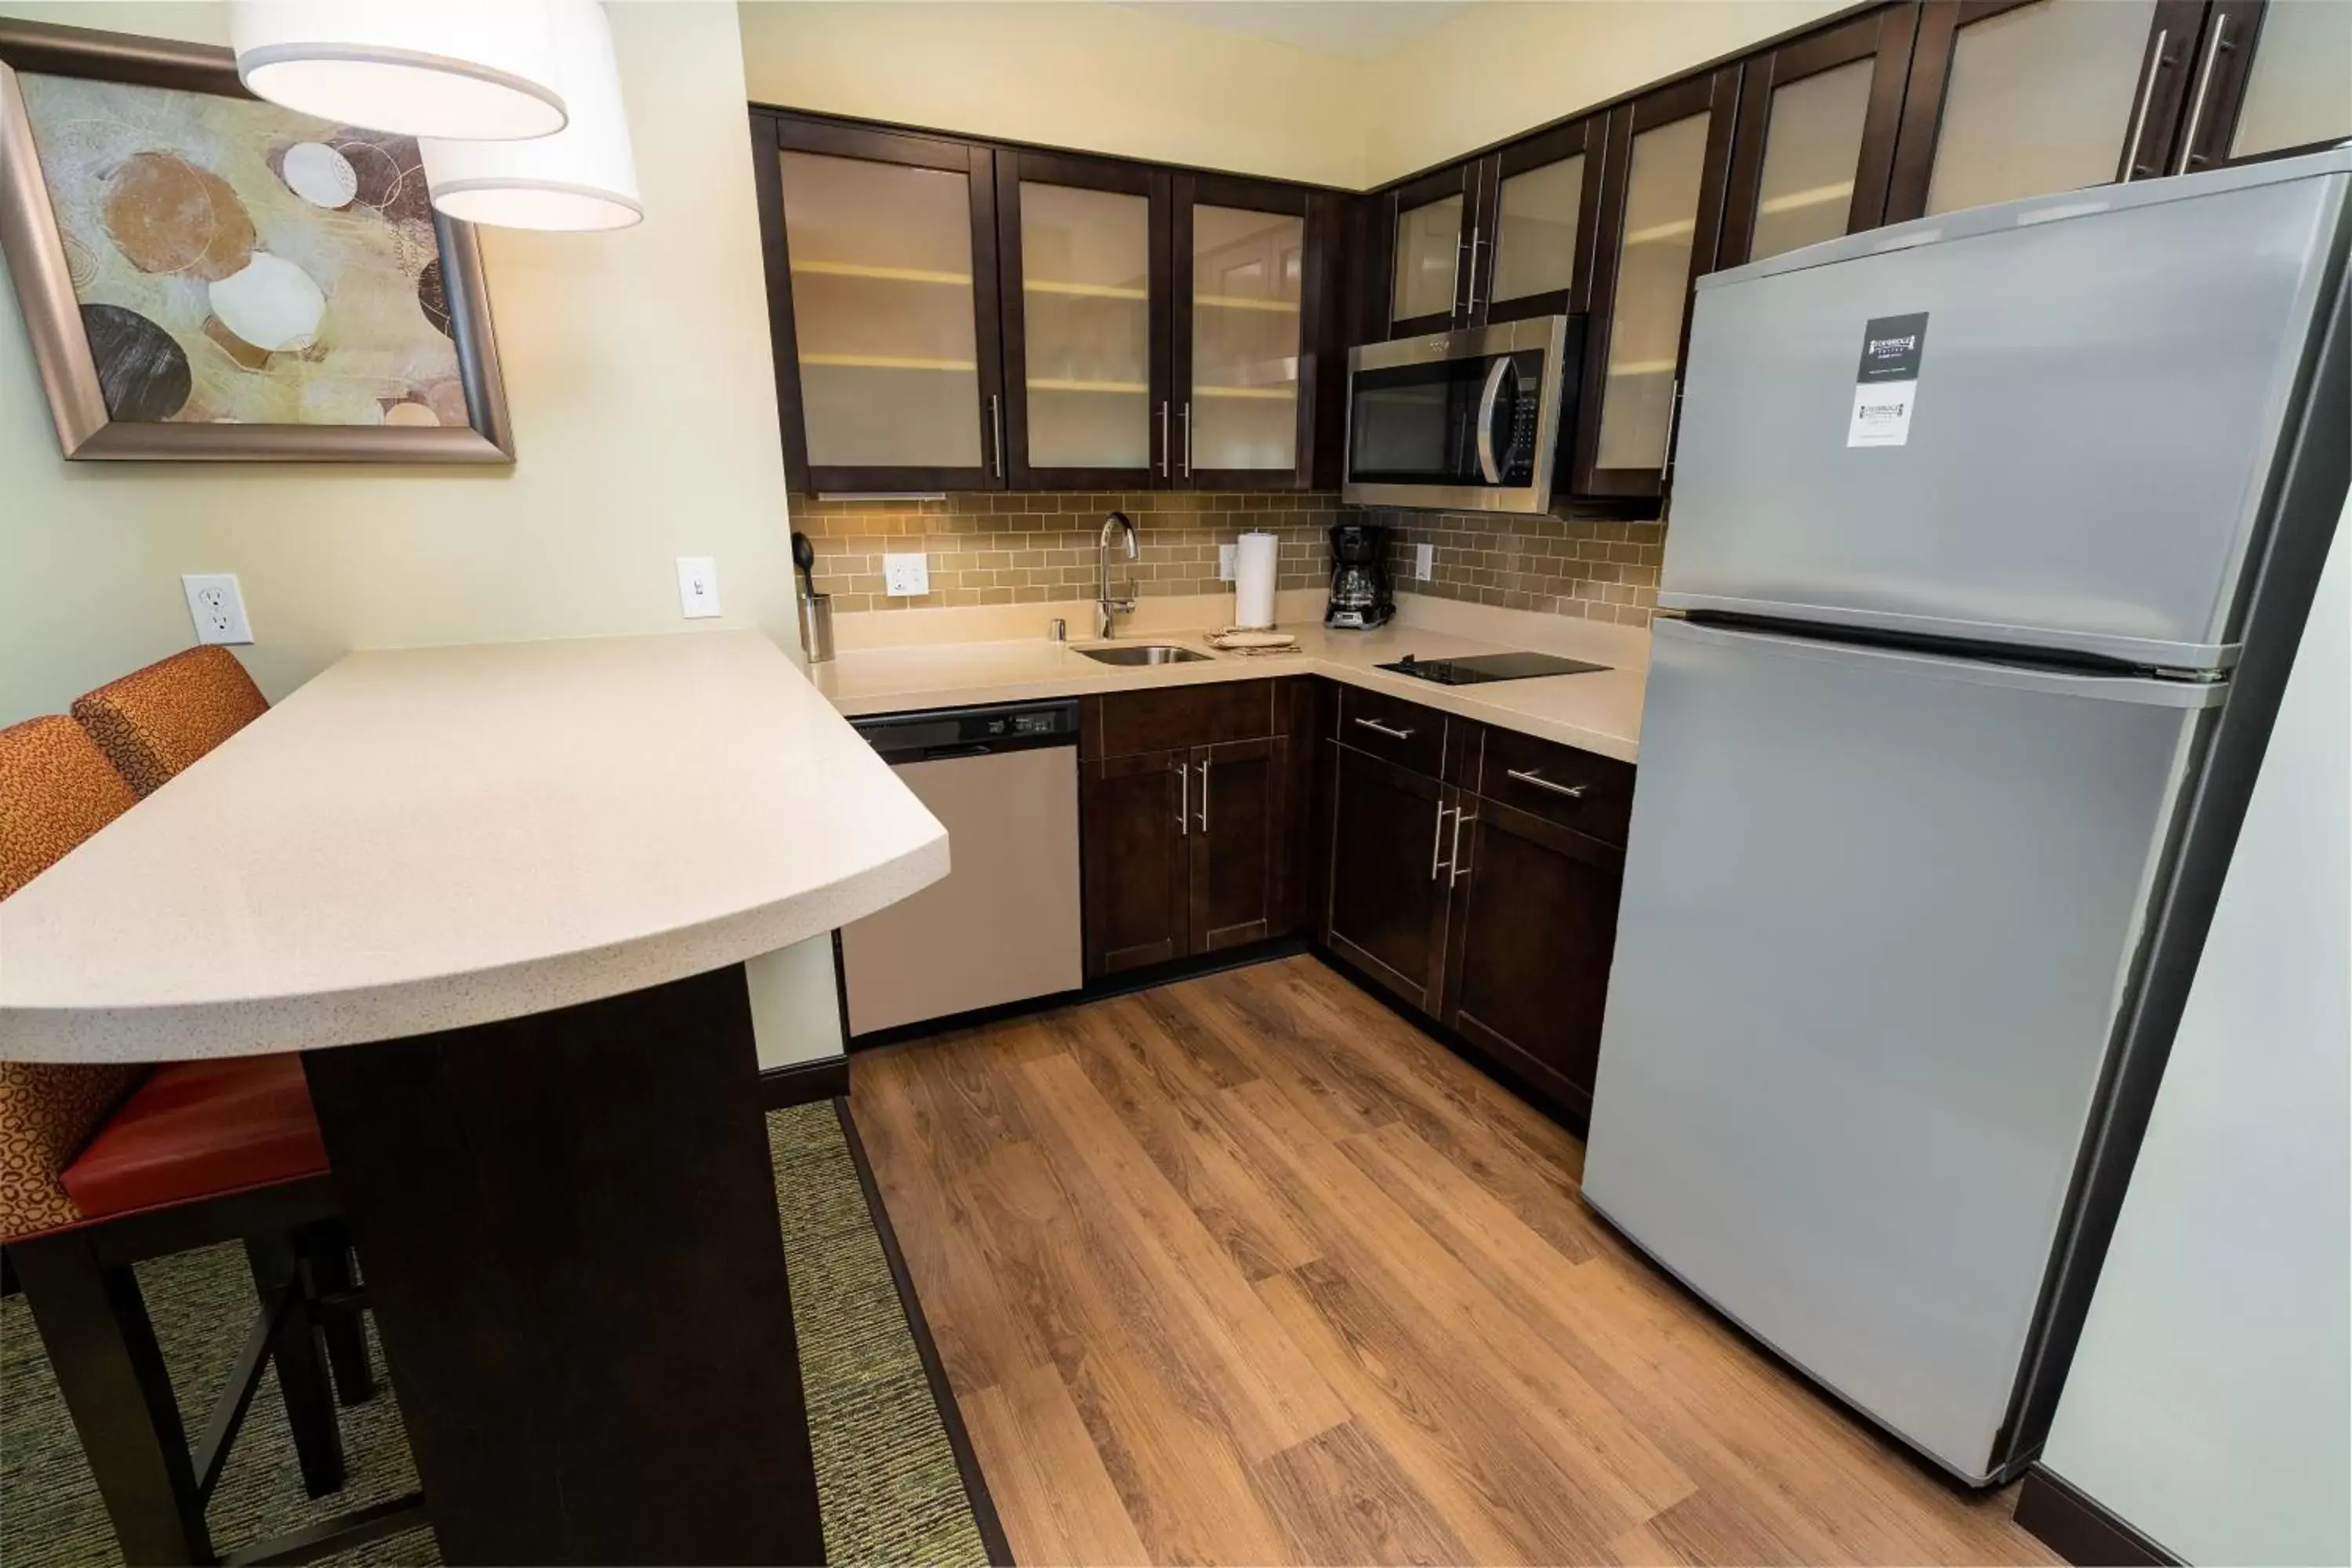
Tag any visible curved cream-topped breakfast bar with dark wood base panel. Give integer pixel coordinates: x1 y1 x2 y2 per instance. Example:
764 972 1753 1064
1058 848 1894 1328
0 633 948 1563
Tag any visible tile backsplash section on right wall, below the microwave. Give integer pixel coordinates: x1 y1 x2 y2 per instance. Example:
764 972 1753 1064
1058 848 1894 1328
1345 506 1665 626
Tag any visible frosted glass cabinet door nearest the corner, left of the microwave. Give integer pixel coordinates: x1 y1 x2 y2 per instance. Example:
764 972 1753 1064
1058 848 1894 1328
1176 196 1308 485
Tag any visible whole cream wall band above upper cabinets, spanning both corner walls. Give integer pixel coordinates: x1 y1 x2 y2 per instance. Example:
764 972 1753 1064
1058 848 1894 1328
741 0 1849 191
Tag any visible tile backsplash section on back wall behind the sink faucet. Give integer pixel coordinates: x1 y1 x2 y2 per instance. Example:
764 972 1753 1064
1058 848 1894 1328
790 492 1341 614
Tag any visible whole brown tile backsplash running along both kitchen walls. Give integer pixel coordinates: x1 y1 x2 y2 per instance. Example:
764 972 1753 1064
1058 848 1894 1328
793 492 1665 626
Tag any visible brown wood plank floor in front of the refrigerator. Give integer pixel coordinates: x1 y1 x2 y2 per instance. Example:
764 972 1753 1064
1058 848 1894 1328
851 956 2056 1563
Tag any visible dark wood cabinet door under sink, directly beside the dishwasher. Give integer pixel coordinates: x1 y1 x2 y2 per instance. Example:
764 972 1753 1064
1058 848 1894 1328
1077 750 1192 975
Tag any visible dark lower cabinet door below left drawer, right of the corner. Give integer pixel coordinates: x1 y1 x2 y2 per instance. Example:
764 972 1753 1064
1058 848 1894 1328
1322 741 1449 1018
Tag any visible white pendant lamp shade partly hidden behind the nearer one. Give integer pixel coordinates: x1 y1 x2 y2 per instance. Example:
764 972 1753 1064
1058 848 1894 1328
419 0 644 230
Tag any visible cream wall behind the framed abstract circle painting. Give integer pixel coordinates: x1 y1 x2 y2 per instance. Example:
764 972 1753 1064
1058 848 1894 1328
0 0 840 1065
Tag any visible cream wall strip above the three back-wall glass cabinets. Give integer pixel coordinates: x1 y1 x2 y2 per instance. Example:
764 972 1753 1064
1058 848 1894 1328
739 0 1364 186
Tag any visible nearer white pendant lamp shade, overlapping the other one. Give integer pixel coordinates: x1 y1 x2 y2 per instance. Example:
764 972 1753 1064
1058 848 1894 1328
228 0 564 141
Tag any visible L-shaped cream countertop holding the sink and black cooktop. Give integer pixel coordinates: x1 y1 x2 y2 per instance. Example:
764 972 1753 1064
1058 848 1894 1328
809 621 1646 762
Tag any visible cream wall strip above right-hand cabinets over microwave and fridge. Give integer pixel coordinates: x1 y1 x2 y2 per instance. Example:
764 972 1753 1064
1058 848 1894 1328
1362 0 1851 186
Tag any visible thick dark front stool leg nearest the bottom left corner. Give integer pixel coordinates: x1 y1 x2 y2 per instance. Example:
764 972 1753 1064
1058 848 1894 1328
9 1232 212 1563
